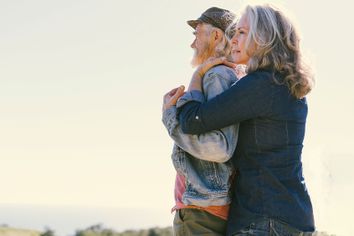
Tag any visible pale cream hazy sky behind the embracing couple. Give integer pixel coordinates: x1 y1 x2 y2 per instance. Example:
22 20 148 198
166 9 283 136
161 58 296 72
0 0 354 236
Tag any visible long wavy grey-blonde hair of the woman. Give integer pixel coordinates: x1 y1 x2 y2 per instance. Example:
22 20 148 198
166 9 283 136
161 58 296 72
244 5 314 98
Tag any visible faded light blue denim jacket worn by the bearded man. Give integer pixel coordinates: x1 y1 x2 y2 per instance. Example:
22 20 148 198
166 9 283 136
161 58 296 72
162 65 238 207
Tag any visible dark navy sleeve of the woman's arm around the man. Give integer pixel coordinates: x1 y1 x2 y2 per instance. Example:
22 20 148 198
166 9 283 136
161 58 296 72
178 73 272 134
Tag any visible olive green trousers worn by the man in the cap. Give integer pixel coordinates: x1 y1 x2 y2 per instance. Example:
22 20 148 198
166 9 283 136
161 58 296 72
173 208 226 236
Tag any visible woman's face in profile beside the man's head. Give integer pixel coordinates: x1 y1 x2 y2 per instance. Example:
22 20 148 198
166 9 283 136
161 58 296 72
231 15 250 65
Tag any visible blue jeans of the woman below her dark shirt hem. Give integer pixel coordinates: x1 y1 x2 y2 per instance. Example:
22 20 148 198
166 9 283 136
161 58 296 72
231 219 312 236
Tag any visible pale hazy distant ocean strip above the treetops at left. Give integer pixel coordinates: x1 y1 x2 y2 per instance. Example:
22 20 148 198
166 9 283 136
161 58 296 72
0 205 173 236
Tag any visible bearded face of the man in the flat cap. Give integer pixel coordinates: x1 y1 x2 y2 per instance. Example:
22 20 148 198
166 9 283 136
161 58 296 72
191 24 212 66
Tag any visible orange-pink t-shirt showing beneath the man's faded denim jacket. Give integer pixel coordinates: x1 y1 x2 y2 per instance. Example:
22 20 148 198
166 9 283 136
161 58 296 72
172 173 230 220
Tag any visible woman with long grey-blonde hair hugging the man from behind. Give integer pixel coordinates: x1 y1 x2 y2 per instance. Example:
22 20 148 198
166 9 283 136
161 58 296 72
163 5 314 236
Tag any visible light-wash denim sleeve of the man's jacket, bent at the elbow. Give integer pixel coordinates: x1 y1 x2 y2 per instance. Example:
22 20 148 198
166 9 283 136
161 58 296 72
163 68 238 162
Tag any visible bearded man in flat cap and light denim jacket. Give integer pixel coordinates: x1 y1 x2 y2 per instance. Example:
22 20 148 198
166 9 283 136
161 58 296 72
162 7 238 236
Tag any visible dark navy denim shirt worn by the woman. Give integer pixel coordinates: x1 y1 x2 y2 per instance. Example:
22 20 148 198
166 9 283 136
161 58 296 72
178 70 314 235
